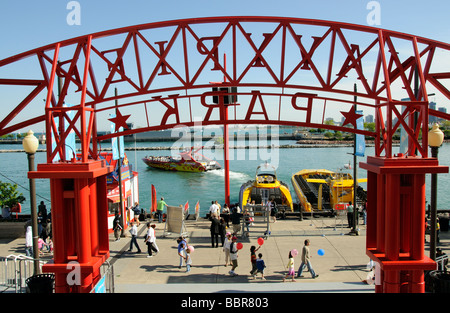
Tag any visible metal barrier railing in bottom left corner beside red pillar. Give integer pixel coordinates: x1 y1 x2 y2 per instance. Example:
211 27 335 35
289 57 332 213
0 254 45 293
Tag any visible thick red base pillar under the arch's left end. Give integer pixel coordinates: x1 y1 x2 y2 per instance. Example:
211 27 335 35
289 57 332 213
28 160 112 293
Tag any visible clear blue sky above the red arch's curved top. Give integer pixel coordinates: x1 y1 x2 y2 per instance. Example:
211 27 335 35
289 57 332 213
0 0 450 132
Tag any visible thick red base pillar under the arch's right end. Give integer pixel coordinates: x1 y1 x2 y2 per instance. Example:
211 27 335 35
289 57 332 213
360 157 448 293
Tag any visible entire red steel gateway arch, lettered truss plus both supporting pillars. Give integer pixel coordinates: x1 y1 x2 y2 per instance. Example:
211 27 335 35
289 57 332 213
0 17 450 292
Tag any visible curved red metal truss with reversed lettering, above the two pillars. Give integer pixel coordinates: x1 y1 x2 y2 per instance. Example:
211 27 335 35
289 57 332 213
0 17 450 162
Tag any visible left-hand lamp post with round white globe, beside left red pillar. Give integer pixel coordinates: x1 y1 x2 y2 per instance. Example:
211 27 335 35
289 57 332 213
22 130 40 275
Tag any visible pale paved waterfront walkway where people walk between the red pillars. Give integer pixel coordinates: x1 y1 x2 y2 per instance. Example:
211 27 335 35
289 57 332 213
0 214 450 293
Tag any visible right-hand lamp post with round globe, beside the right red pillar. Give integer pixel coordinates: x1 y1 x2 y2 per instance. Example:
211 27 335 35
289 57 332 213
428 124 444 260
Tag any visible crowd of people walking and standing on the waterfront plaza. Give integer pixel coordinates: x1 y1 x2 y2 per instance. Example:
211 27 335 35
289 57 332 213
26 197 447 281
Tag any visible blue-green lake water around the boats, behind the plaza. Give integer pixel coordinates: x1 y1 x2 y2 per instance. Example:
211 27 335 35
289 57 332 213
0 141 450 216
